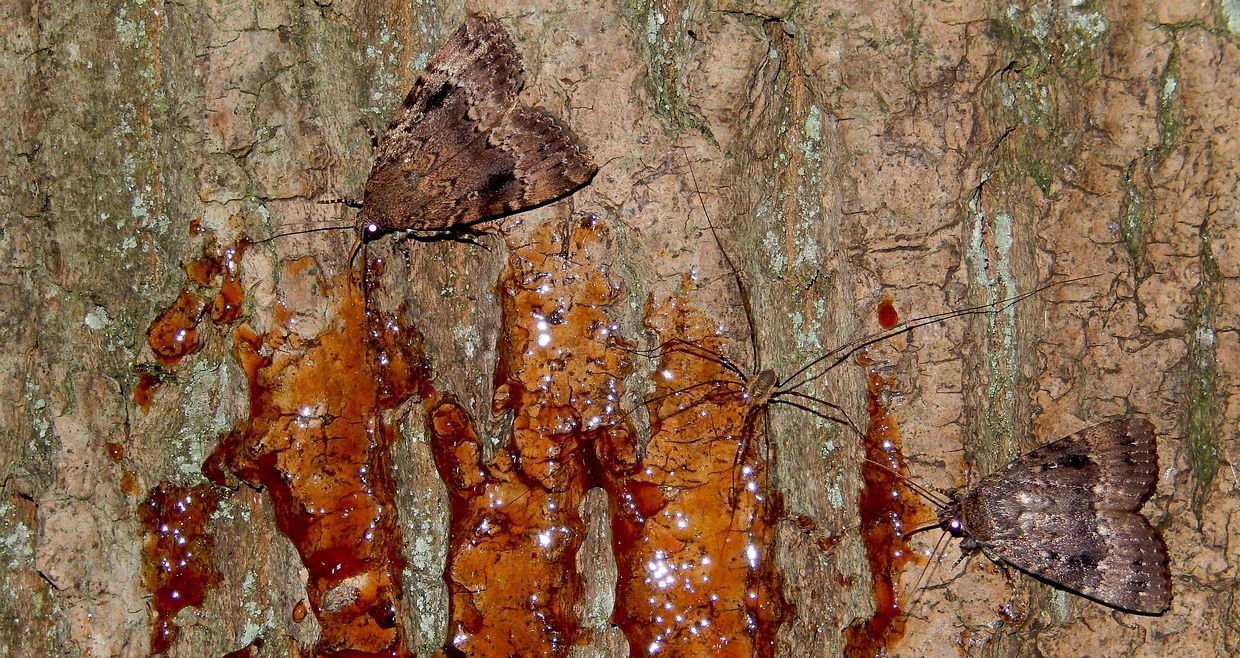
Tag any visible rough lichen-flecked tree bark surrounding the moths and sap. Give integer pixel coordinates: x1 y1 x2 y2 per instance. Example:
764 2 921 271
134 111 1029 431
0 0 1240 657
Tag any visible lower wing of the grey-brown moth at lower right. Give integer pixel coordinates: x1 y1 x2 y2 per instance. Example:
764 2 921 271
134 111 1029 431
986 511 1171 615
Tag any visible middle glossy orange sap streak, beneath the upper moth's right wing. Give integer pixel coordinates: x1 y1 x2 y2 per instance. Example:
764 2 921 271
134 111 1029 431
430 218 635 656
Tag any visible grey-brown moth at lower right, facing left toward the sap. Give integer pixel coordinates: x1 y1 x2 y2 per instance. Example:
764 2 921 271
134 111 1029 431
932 419 1171 615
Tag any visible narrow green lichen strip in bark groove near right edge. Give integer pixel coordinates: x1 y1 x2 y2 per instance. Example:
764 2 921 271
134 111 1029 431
1185 224 1223 523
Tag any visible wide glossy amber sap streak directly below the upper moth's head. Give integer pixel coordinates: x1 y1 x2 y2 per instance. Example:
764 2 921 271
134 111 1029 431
203 268 430 656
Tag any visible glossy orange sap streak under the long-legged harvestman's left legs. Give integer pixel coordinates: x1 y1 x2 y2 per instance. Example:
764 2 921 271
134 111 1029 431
608 297 790 656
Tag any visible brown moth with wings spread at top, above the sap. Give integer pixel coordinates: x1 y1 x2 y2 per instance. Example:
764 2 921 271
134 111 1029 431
357 14 598 238
